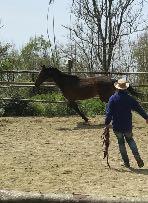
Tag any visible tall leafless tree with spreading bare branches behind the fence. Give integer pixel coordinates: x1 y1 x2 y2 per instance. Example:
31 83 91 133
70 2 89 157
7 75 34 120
67 0 147 72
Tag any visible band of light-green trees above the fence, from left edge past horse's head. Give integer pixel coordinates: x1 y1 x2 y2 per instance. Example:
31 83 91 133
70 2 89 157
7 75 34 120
0 35 61 74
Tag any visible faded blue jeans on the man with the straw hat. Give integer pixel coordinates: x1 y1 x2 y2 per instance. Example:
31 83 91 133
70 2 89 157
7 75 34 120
114 131 141 164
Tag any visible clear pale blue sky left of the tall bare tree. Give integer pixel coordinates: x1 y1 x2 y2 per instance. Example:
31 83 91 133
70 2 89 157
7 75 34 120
0 0 70 49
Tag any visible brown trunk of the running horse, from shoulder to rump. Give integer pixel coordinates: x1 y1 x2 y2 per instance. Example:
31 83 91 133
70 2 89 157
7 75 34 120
62 76 114 102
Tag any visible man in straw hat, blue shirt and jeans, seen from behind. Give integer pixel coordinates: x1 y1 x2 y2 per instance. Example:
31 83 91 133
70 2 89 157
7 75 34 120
105 79 148 168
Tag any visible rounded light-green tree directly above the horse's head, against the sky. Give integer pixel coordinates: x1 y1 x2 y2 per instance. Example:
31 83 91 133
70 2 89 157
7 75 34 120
20 35 60 70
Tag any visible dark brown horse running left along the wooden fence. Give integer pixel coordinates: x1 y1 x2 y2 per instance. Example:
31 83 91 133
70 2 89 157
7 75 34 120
35 66 138 122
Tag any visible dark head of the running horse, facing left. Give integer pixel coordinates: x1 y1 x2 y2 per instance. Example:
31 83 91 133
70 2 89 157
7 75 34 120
35 65 54 87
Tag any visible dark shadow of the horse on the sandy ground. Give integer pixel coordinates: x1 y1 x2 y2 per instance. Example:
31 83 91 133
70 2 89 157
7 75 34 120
57 122 104 131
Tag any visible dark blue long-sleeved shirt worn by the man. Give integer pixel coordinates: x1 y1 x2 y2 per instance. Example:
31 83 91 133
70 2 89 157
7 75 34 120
105 90 148 133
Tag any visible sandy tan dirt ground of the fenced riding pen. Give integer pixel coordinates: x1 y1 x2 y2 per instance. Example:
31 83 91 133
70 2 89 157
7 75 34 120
0 114 148 198
